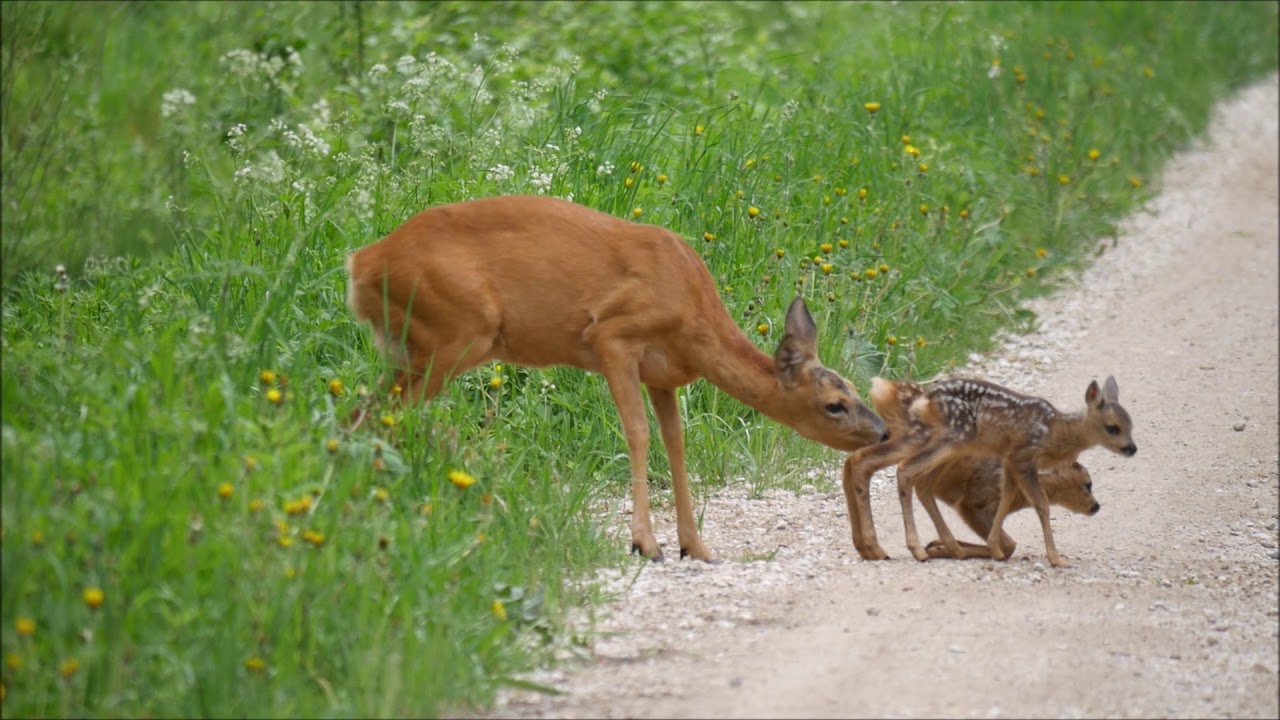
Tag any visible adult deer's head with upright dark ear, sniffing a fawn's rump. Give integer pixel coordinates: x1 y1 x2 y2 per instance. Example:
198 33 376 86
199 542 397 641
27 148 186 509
773 296 884 452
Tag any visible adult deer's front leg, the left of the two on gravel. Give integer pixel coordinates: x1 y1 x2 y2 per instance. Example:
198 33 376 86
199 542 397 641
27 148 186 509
596 348 663 562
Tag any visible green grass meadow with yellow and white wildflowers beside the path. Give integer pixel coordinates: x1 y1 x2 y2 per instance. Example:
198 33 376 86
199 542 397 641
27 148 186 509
0 3 1277 717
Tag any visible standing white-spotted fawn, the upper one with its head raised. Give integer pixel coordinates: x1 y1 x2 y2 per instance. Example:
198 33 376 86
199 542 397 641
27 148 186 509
844 377 1138 568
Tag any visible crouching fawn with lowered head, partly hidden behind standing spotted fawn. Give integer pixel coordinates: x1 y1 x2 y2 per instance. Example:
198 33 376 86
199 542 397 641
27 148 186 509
915 457 1102 559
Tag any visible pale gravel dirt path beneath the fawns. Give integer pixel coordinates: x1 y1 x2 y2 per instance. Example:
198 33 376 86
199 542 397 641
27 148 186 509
495 78 1280 717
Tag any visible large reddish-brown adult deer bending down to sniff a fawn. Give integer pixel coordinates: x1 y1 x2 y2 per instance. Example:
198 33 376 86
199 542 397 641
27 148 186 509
347 196 884 560
